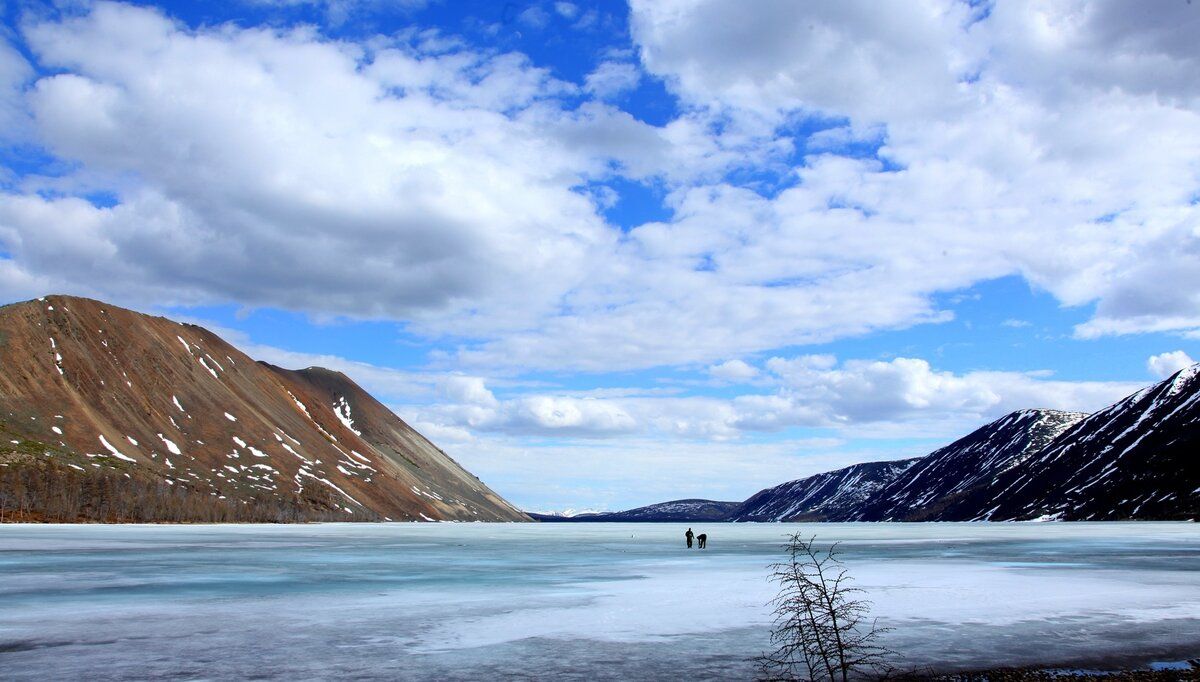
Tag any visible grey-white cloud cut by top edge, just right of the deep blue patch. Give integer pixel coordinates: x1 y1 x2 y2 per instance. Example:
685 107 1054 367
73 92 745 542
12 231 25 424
631 0 971 122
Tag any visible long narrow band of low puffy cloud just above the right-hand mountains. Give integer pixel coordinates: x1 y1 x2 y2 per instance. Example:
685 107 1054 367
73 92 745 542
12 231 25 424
408 355 1141 441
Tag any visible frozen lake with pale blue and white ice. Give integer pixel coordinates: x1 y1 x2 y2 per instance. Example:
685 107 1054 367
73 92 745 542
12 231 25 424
0 524 1200 681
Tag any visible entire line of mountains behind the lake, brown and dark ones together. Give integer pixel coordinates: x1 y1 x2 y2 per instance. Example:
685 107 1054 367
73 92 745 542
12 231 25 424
0 297 1200 522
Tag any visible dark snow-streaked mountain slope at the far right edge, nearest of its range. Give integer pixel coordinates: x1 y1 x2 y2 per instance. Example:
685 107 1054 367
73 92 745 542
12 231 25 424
941 364 1200 521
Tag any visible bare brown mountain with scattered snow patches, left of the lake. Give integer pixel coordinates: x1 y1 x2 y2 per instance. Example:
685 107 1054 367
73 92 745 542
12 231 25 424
0 295 529 521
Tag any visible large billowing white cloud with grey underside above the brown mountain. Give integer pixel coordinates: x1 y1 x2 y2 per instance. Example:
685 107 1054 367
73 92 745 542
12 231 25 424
0 4 612 333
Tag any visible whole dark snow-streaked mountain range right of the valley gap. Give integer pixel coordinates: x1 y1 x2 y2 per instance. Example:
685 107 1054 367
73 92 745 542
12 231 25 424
554 364 1200 521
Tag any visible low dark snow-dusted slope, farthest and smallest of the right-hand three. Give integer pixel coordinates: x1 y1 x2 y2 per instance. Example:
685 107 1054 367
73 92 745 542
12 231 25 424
730 460 918 521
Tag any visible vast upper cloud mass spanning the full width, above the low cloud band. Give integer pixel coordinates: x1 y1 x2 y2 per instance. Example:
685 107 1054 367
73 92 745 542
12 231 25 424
0 0 1200 373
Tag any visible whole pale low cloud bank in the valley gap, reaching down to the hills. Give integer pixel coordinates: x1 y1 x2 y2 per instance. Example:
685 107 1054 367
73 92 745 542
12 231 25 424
422 355 1140 509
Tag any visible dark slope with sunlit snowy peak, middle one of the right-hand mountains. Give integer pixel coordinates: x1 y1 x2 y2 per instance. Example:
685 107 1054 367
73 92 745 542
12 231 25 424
841 409 1087 521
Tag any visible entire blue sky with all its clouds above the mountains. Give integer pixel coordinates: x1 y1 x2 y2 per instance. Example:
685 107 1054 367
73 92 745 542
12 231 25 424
0 0 1200 510
